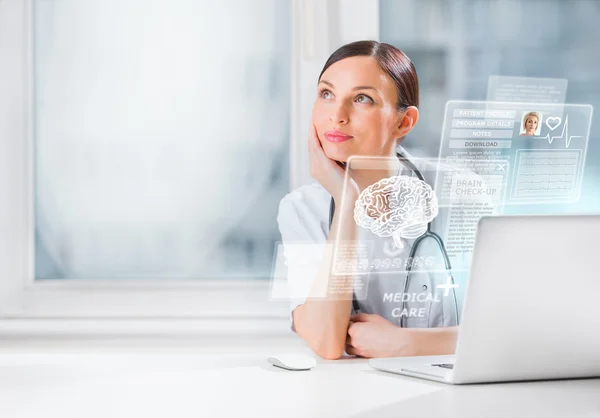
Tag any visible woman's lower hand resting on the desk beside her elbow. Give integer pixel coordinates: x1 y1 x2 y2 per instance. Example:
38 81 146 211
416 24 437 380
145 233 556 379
346 313 415 358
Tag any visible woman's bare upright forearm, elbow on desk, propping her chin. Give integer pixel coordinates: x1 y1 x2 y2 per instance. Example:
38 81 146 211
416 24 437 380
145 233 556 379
292 193 356 359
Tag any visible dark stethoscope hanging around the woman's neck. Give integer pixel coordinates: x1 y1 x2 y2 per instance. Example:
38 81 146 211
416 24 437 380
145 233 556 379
329 152 459 327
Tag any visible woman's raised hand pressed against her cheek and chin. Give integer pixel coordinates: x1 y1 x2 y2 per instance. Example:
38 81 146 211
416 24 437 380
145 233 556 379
308 121 360 205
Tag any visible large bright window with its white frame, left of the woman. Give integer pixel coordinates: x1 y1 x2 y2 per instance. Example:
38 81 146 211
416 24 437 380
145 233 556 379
0 0 378 329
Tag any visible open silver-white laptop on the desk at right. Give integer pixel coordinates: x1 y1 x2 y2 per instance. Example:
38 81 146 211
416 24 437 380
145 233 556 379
369 215 600 384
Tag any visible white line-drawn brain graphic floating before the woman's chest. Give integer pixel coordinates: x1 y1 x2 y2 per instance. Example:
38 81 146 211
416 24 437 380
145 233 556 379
354 176 438 248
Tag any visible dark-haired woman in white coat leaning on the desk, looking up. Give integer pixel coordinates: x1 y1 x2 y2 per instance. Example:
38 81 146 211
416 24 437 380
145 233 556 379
278 41 458 359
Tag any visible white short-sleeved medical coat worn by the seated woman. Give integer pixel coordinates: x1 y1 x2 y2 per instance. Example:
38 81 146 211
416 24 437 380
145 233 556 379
277 149 464 330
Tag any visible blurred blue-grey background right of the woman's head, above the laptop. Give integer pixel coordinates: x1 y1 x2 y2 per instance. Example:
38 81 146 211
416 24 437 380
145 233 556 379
380 0 600 219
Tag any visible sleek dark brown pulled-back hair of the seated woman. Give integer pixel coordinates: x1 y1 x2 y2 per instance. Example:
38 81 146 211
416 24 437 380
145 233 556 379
319 41 419 111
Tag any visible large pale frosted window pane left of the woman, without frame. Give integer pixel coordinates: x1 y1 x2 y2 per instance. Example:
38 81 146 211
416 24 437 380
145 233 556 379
32 0 291 280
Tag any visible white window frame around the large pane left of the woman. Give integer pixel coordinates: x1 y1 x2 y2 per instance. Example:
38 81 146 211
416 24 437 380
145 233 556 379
0 0 379 333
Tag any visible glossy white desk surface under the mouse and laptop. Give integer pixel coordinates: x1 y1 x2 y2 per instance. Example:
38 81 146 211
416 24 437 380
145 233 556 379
0 339 600 418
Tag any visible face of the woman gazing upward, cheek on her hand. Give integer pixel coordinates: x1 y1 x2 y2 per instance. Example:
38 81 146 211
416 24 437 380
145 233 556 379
312 56 403 162
